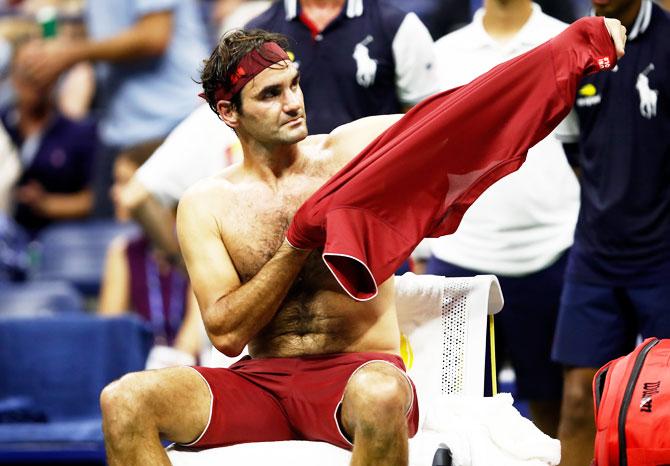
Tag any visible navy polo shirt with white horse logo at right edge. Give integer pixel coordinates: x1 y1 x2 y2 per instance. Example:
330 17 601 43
567 0 670 286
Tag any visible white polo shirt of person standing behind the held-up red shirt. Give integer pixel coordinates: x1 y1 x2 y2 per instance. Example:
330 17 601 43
430 4 579 276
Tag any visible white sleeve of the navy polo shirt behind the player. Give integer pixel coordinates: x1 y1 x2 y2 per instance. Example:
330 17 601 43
392 13 438 105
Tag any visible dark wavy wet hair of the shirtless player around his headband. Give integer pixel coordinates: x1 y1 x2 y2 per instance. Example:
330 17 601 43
200 29 289 114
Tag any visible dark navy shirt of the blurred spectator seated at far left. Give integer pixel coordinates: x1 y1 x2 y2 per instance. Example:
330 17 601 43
0 108 98 231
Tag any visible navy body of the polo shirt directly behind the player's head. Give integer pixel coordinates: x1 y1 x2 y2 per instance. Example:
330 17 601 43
246 0 434 134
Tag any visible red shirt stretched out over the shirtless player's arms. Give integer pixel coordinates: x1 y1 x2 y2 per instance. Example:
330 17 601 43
287 18 616 301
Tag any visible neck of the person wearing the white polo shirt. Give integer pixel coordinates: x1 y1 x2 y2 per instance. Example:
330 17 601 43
483 0 533 42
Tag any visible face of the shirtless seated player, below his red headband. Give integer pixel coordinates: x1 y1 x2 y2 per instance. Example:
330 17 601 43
239 61 307 144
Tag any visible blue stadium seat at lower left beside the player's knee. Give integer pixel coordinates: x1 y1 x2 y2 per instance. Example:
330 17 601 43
0 314 152 463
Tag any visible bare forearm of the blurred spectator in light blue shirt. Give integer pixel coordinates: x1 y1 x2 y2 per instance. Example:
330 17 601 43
71 12 172 63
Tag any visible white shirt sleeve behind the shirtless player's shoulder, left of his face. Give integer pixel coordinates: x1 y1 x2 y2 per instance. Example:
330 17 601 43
135 104 242 206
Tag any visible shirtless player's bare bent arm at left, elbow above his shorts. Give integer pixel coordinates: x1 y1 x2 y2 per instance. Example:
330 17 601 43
177 182 309 356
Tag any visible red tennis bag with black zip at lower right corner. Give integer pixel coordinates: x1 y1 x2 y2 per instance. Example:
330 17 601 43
593 338 670 466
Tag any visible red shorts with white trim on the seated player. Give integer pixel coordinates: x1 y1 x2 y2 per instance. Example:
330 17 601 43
181 353 419 449
